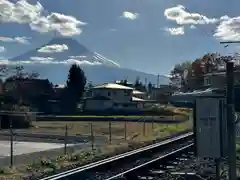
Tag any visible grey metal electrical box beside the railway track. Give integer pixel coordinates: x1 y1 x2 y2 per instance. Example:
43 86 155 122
194 96 228 159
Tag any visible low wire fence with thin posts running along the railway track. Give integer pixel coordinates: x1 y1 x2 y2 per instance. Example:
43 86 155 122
0 114 191 166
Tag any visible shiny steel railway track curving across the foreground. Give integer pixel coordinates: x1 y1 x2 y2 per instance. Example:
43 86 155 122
41 133 194 180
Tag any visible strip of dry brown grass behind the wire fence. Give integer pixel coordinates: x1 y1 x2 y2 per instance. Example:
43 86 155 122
31 121 192 140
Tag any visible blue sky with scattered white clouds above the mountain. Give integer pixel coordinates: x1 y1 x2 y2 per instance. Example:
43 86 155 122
0 0 240 74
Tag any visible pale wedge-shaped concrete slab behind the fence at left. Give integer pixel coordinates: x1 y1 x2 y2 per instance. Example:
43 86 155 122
0 141 73 158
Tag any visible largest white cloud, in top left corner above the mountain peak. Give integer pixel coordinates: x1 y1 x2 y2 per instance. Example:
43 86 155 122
0 0 86 36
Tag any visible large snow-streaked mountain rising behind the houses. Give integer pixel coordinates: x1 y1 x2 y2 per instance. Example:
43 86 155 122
9 38 170 84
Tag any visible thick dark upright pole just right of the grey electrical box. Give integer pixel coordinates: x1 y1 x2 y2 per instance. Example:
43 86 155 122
226 62 237 180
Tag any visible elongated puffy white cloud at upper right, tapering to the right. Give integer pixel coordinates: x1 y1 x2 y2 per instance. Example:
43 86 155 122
164 5 219 25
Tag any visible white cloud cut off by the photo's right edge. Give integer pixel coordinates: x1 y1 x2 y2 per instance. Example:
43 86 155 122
213 16 240 41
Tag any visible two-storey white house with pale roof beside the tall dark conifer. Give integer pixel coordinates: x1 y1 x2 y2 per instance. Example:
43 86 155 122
84 83 147 111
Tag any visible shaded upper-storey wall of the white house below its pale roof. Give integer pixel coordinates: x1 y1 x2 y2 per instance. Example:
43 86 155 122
91 89 132 103
